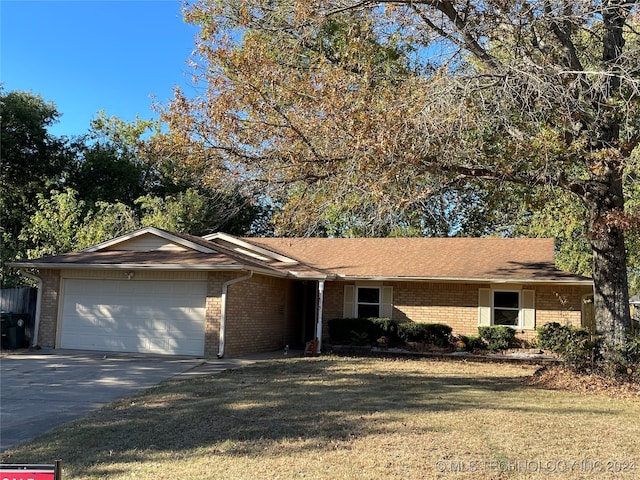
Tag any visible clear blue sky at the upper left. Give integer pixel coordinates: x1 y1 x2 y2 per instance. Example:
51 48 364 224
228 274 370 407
0 0 197 136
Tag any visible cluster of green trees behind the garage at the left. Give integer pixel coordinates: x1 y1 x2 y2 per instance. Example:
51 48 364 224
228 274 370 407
0 90 268 287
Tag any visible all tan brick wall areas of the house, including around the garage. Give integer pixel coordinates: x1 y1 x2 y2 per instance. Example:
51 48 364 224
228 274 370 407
38 264 592 356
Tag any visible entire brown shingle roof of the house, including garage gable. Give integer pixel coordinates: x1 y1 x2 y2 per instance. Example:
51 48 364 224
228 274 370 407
7 229 590 283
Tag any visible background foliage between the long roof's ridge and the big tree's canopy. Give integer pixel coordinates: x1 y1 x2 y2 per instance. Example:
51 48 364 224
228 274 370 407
272 181 534 237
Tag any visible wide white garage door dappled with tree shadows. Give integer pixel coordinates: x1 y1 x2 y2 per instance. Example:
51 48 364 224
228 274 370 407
61 279 207 355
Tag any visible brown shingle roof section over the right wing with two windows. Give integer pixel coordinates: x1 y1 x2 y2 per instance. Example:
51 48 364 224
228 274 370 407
245 238 588 281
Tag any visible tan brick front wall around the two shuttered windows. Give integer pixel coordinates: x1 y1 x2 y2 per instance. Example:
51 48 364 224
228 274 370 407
323 282 593 340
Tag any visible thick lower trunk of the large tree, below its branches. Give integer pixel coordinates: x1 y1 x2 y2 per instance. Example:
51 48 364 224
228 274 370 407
587 175 631 360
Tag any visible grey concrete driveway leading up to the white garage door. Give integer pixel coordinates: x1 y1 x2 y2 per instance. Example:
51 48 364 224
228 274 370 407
0 350 282 452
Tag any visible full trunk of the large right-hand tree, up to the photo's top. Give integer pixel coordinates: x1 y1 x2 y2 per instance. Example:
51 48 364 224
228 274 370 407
586 0 631 364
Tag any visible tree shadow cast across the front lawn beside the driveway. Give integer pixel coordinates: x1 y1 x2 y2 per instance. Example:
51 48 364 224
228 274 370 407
2 359 606 476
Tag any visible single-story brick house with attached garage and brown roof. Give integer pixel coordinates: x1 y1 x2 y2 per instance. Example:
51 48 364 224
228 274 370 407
10 227 593 356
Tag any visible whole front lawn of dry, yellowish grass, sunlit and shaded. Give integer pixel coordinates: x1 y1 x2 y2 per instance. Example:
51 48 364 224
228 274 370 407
1 357 640 480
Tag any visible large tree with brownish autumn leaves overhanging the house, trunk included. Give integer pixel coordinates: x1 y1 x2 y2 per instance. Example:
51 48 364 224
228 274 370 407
163 0 640 360
